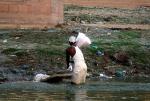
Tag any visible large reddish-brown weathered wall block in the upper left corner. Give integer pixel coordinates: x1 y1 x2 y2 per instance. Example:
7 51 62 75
0 0 63 28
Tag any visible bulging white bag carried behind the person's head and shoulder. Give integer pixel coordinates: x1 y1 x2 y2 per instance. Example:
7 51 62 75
76 32 91 47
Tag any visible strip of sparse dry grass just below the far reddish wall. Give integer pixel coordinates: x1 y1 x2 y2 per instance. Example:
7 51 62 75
65 6 150 24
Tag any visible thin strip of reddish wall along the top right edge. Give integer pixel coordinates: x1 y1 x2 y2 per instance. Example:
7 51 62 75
64 0 150 8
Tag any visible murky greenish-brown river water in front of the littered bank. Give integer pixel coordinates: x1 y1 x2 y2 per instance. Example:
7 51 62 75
0 81 150 101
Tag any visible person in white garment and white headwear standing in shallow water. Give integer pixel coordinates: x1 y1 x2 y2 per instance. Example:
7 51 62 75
66 36 87 84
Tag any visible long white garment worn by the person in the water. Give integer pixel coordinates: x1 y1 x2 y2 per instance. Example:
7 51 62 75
72 46 87 84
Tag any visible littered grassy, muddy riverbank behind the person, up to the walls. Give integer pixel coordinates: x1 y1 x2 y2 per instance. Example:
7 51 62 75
0 6 150 82
